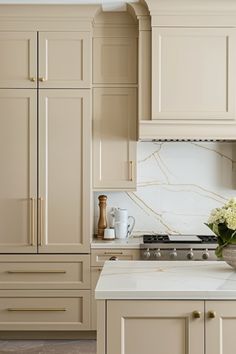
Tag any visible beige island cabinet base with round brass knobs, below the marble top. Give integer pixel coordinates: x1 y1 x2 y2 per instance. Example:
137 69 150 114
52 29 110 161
98 300 236 354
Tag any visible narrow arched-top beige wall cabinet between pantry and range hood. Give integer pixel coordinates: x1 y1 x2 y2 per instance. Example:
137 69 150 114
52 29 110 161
93 12 138 191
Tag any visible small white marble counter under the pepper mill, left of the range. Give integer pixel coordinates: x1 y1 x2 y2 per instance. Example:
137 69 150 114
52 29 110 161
91 236 143 249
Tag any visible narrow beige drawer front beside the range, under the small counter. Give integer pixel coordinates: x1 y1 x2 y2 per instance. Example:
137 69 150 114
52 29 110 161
91 249 140 267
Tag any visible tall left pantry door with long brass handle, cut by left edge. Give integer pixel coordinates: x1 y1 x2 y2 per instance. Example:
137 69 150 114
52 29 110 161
0 89 37 253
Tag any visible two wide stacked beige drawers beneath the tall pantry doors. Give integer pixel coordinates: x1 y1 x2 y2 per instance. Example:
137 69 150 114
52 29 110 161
0 254 91 331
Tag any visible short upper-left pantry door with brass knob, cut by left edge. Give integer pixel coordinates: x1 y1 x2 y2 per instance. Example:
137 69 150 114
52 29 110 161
0 32 37 88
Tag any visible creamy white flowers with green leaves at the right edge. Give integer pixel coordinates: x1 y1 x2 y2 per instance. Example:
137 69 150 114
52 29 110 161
205 198 236 258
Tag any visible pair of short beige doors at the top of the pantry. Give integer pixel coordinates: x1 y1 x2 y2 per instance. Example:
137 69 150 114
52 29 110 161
0 31 92 88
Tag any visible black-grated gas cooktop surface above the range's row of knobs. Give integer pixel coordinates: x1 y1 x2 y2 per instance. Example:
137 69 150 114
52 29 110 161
143 234 217 244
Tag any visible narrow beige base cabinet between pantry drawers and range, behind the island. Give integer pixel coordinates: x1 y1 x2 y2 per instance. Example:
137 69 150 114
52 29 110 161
91 249 140 330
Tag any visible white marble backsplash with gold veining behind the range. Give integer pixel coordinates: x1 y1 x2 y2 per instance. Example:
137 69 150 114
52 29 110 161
94 142 236 234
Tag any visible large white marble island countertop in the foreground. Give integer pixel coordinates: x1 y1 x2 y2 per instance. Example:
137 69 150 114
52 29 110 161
95 261 236 300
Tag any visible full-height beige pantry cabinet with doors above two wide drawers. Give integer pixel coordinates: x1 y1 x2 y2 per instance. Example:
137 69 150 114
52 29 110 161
0 5 99 331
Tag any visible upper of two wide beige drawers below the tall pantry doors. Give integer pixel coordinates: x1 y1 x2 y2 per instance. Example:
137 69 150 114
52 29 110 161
0 255 90 289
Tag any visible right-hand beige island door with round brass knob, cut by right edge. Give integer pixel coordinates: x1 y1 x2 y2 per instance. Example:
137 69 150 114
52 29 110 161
206 301 236 354
